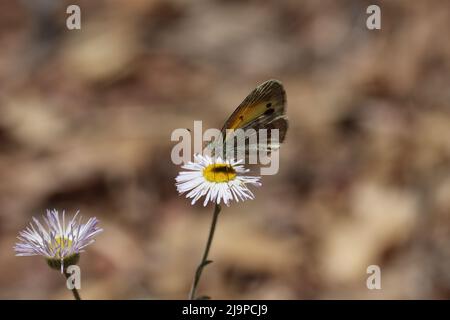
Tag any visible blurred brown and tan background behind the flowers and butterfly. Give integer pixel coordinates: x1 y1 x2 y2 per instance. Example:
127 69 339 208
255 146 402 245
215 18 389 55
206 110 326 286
0 0 450 299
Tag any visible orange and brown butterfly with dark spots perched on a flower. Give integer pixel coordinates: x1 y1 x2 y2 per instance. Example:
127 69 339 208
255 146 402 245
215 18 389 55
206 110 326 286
207 79 288 158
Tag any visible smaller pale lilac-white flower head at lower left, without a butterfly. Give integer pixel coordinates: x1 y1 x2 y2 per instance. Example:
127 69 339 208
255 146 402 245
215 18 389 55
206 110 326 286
14 210 103 272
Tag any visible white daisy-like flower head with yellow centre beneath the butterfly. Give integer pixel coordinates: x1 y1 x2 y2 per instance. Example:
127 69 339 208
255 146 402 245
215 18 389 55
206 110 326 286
175 154 261 206
